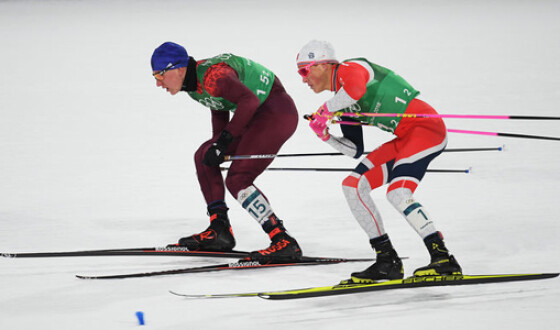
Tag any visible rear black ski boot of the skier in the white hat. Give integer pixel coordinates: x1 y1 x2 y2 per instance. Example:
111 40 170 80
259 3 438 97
414 231 462 276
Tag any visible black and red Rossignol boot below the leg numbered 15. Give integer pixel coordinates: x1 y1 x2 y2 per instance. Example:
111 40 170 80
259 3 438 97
245 216 302 263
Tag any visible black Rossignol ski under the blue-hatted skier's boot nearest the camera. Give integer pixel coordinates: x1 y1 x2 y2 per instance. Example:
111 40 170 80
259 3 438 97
76 257 374 280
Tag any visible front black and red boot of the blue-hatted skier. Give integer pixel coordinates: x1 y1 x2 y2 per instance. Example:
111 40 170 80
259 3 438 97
175 212 235 252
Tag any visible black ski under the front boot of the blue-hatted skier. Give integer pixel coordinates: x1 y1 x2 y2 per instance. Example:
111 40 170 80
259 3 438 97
0 247 249 258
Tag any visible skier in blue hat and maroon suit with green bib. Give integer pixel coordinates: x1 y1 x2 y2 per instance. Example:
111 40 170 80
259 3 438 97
151 42 302 261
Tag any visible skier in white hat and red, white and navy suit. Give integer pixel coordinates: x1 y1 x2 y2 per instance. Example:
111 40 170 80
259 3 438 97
297 40 461 283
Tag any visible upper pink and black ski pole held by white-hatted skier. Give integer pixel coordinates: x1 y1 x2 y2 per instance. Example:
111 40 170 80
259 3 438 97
334 112 560 120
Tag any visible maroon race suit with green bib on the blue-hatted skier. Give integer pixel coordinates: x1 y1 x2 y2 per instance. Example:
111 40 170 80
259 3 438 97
184 54 298 204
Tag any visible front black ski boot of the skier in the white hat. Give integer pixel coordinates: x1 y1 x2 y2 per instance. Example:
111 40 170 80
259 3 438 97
345 234 404 284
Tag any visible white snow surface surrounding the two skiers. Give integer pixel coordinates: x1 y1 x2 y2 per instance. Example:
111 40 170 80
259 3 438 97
0 0 560 330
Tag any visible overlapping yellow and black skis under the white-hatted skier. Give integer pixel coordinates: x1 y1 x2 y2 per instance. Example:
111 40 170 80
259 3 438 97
170 273 558 300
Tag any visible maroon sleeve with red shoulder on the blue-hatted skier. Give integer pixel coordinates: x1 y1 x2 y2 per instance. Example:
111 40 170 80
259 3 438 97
203 63 260 137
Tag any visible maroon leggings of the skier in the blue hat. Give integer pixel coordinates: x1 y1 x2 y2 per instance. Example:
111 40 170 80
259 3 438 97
194 80 298 204
